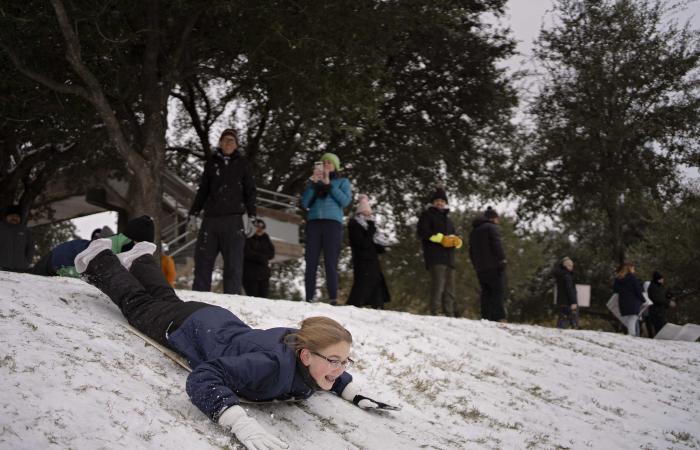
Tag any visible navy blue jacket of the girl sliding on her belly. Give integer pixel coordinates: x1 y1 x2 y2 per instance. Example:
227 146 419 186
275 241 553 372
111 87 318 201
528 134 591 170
168 306 352 421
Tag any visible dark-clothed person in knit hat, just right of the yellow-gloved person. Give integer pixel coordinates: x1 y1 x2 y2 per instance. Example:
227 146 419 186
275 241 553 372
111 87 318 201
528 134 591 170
469 206 506 322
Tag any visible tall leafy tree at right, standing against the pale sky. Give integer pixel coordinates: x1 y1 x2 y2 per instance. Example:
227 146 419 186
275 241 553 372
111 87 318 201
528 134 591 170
513 0 700 264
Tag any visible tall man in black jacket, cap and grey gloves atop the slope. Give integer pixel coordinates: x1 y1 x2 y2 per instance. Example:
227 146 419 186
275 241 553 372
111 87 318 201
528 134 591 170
190 128 256 294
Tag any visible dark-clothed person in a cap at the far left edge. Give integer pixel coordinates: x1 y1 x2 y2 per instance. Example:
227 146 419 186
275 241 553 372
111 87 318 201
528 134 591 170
0 205 34 270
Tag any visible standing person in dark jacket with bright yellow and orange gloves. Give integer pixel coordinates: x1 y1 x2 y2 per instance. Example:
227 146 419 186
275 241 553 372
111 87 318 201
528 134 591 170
416 187 462 317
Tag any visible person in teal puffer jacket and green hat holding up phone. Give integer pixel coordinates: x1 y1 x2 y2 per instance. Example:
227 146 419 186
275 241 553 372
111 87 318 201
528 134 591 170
301 153 352 305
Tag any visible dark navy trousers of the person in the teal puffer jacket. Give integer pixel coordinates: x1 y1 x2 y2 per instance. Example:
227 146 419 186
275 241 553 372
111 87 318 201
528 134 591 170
304 220 343 300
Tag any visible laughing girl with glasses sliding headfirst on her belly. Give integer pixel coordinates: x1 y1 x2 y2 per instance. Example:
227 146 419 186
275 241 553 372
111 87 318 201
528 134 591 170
75 239 394 449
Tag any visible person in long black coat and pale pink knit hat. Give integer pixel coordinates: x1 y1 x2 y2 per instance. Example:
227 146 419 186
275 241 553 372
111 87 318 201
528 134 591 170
346 194 391 309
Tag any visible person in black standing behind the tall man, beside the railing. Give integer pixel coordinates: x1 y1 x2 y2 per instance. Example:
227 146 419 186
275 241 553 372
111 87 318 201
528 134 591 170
243 219 275 298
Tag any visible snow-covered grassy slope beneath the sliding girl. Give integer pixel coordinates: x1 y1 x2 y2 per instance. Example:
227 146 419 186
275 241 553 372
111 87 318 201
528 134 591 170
0 272 700 450
